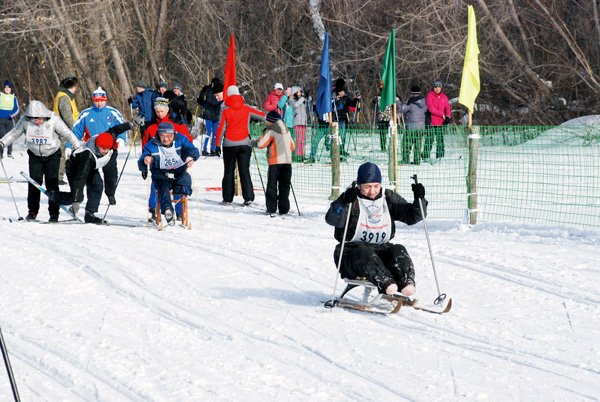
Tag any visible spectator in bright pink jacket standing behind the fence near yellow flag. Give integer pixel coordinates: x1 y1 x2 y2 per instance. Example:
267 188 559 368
422 80 452 161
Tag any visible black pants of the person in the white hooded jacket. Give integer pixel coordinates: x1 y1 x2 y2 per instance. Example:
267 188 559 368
27 149 61 216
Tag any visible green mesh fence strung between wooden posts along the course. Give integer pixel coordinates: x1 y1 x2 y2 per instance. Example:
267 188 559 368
251 125 600 227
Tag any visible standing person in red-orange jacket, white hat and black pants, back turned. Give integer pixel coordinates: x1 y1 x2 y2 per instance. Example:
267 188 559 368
217 85 265 205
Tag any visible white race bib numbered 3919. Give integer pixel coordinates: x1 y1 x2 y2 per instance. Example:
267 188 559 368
352 192 392 244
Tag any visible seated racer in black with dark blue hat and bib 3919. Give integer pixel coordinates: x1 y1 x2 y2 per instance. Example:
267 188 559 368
325 162 427 296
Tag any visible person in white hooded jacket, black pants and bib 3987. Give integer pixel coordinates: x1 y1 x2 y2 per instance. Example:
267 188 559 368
0 100 81 222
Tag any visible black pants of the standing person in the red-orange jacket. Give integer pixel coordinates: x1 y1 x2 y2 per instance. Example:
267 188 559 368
222 145 254 202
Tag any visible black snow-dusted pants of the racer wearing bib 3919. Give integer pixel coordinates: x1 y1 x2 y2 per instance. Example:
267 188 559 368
333 242 415 293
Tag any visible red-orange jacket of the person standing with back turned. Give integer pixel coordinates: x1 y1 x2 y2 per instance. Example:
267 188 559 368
216 95 265 146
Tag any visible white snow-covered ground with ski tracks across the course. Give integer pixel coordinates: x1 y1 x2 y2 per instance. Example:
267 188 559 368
0 140 600 401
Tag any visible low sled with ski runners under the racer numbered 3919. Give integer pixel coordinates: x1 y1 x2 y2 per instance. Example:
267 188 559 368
325 278 452 315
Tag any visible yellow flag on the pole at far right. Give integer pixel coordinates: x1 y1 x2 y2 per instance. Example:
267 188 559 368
458 6 480 113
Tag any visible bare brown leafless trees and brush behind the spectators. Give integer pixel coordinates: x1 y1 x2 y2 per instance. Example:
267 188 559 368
0 0 600 125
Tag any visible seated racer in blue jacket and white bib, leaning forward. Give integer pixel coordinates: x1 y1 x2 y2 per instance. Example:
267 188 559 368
138 123 200 226
